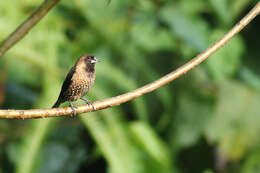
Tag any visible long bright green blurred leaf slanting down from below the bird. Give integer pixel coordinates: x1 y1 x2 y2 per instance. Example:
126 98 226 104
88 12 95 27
81 113 143 173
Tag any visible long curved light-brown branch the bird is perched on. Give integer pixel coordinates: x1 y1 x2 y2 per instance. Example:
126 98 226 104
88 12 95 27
0 2 260 119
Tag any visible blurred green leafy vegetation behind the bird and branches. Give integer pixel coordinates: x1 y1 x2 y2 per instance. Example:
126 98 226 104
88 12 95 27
0 0 260 173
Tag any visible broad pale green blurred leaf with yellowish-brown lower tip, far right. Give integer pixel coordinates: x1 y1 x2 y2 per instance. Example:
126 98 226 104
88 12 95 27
205 81 260 160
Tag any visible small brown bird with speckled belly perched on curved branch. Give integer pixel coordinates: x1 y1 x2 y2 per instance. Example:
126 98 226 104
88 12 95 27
52 54 99 115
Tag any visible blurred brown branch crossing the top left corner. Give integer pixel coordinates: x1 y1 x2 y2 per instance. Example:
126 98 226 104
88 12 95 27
0 0 60 57
